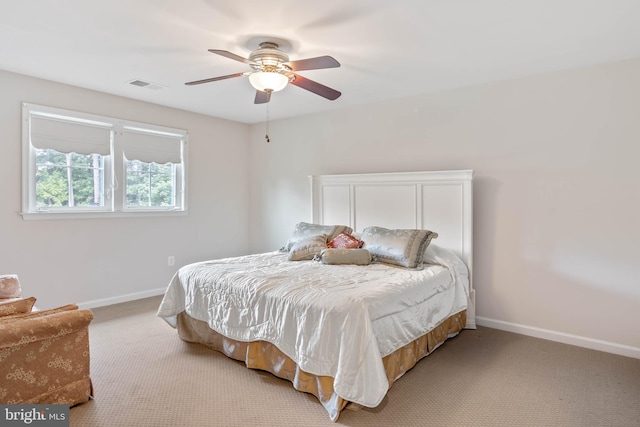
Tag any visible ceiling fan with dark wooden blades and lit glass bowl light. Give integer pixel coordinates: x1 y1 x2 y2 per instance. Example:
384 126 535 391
185 41 342 104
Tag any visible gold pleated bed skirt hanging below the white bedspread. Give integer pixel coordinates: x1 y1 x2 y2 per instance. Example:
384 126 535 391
178 311 467 422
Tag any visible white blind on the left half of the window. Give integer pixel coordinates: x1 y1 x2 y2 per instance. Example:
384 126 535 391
31 114 111 156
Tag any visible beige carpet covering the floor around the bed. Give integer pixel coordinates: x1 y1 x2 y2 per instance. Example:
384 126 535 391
71 297 640 427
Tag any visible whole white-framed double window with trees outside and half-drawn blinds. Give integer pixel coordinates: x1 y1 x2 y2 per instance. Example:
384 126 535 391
22 104 187 219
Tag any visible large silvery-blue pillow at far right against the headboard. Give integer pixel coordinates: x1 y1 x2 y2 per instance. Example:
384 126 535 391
362 227 438 268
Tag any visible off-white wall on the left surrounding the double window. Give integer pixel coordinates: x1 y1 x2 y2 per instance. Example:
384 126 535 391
0 71 249 308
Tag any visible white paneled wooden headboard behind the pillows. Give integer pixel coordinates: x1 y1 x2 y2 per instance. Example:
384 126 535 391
309 170 475 326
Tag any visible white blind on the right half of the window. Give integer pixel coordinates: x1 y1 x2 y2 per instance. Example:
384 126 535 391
122 127 182 164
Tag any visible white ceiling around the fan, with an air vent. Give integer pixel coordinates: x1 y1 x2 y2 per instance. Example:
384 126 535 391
0 0 640 123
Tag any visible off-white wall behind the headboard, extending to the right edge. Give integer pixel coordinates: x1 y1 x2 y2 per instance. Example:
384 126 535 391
250 60 640 357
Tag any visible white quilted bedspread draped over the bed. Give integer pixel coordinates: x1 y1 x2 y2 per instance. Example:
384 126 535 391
158 245 469 407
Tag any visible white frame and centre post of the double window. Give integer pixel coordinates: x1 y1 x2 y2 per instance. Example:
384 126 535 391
21 102 189 220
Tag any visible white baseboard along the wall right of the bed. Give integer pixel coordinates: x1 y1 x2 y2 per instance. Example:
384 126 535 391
476 316 640 359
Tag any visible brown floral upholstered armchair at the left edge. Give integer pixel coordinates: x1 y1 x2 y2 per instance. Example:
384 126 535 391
0 276 93 406
